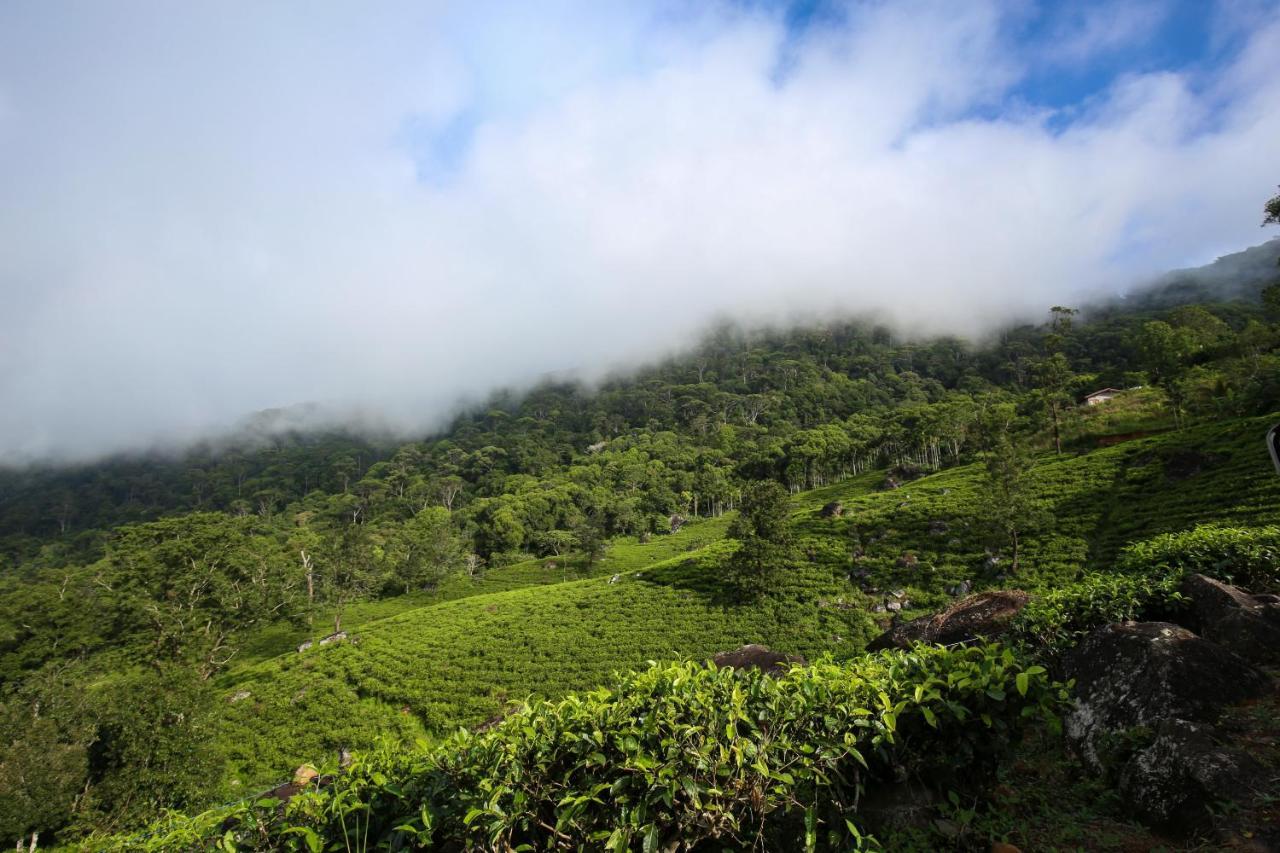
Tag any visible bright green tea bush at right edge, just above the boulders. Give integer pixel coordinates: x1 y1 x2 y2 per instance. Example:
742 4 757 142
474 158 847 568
1117 524 1280 593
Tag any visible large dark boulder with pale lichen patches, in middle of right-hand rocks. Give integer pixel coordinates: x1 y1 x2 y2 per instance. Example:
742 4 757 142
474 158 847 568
1064 622 1268 771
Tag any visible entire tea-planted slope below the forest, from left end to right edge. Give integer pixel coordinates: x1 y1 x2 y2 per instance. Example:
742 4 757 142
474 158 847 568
204 419 1280 790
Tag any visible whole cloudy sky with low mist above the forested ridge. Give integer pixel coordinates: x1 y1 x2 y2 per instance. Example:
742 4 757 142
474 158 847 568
0 0 1280 461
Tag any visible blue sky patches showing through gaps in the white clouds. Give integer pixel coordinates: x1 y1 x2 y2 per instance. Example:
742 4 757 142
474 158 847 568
404 0 1274 184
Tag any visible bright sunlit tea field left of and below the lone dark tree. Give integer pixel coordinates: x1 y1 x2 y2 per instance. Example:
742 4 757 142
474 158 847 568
223 546 867 783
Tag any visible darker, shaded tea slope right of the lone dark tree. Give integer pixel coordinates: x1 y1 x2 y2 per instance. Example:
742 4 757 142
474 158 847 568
799 418 1280 610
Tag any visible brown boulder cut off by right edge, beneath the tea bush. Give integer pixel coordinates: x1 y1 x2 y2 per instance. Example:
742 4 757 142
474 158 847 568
1181 575 1280 663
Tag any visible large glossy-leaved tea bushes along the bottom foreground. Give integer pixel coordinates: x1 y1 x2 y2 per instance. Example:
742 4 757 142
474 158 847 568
112 646 1066 850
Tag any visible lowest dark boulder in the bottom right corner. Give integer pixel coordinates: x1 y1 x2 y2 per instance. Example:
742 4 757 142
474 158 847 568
1119 720 1266 833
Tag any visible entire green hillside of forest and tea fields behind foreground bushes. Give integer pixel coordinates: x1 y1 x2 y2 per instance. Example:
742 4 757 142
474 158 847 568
0 234 1280 841
